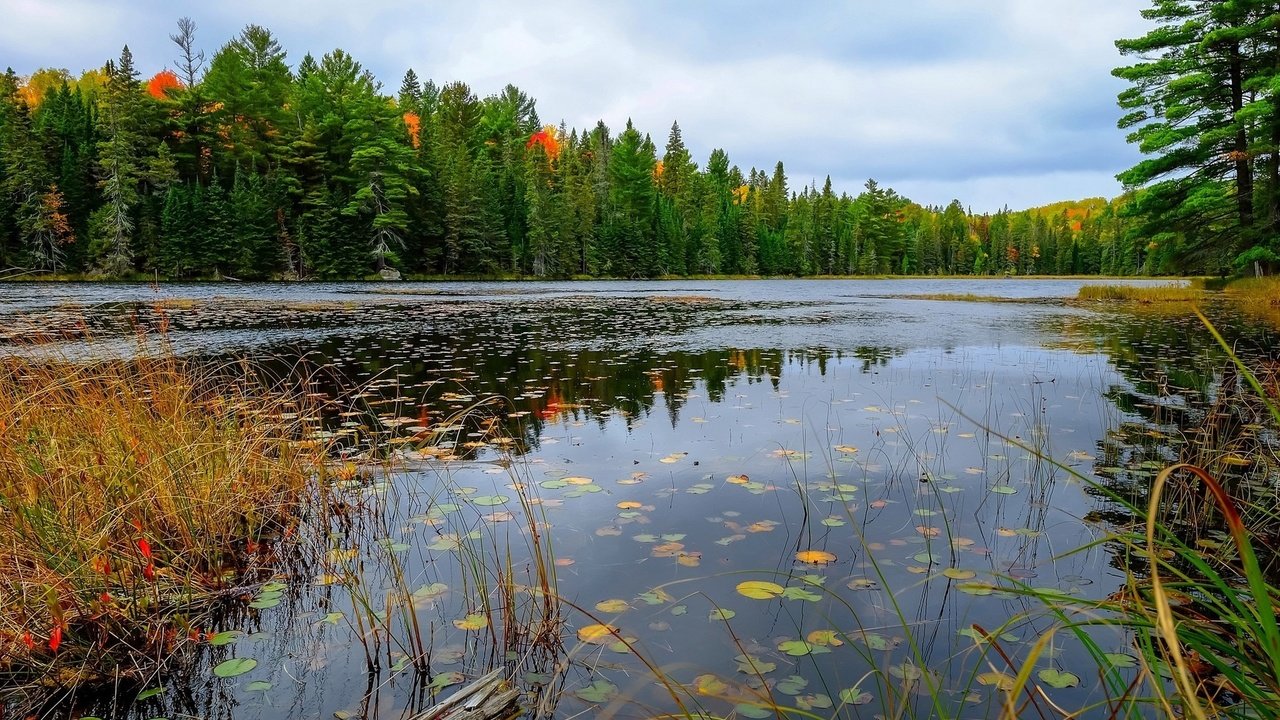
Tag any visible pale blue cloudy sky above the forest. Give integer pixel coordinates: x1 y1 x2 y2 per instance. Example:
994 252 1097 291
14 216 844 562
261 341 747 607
0 0 1149 211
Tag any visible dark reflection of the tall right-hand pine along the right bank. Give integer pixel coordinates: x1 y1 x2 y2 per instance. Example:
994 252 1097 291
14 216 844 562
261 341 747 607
1074 308 1280 577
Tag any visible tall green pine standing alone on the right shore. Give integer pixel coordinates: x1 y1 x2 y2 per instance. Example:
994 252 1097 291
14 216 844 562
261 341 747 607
1115 0 1280 272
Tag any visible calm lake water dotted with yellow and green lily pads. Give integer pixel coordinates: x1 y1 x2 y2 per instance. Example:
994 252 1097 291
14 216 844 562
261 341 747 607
0 279 1270 720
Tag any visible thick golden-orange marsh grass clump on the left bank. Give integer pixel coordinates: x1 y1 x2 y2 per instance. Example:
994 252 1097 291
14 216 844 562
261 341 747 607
0 354 325 687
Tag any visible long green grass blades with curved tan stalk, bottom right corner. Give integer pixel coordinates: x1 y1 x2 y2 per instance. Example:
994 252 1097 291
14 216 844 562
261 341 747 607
967 313 1280 720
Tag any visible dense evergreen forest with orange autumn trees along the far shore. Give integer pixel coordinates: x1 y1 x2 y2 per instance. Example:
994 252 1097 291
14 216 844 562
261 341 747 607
0 19 1157 279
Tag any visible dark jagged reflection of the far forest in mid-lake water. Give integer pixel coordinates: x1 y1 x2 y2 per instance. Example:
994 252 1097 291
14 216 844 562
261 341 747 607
240 332 902 456
